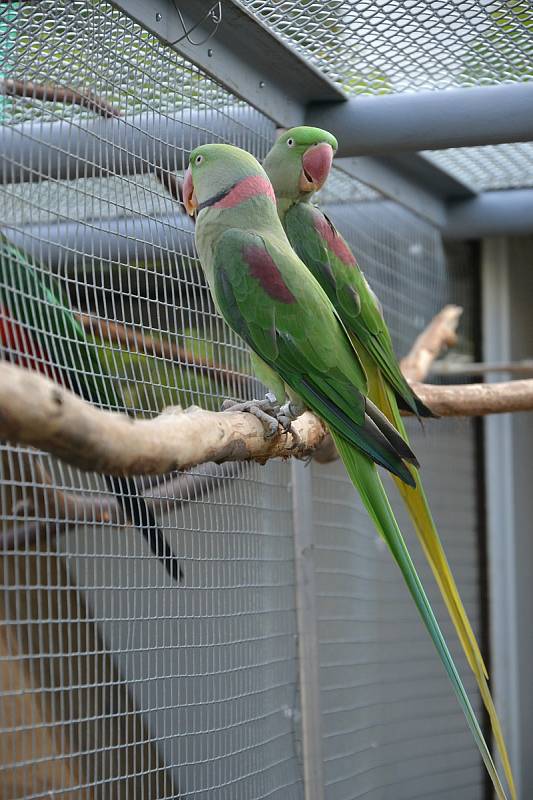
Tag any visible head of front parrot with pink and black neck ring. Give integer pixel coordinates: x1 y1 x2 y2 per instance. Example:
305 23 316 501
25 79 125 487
183 144 275 216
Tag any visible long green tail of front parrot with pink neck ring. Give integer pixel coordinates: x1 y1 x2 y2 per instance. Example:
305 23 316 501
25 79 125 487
331 432 506 800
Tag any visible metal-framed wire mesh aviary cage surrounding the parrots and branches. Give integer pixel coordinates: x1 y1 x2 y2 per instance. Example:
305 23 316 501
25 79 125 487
0 0 533 800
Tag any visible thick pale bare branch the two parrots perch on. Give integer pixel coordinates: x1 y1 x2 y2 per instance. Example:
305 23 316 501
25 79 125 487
0 364 533 482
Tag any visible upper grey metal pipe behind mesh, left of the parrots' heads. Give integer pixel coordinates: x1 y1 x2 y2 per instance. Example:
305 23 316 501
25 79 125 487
0 106 265 183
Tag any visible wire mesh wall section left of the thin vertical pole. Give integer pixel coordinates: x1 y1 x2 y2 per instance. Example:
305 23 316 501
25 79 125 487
0 0 301 800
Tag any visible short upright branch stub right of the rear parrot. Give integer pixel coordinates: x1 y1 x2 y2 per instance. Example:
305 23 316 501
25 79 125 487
400 305 463 382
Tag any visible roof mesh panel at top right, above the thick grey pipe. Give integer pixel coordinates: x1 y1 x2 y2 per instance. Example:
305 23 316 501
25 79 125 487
241 0 533 94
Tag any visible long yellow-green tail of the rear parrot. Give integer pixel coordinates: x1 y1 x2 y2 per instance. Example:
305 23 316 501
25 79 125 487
371 376 516 800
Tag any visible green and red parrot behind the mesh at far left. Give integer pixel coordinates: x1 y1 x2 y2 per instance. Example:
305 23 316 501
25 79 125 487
0 234 181 580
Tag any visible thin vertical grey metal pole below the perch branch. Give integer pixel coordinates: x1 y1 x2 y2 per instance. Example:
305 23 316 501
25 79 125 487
291 458 324 800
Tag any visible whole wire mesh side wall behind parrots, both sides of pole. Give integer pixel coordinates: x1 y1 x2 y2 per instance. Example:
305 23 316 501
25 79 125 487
0 0 488 800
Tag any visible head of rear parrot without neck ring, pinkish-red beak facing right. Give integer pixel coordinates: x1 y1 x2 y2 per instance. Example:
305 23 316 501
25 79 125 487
263 125 338 202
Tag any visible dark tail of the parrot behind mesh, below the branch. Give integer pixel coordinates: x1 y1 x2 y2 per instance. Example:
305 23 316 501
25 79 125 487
106 475 183 582
